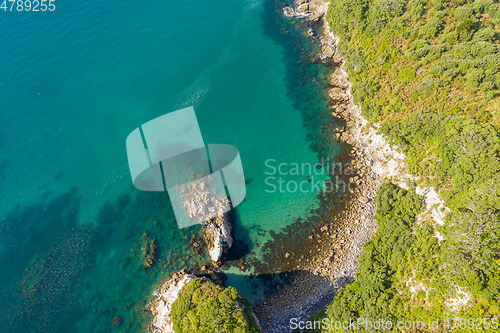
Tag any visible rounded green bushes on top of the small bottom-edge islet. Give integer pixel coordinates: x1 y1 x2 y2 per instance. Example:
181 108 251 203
171 278 260 333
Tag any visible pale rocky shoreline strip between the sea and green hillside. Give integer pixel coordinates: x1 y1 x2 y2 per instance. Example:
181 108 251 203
255 0 414 333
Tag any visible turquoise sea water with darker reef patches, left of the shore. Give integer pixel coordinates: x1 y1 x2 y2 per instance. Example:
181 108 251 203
0 0 338 332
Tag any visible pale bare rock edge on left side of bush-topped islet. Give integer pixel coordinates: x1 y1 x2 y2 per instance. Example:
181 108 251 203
149 271 198 333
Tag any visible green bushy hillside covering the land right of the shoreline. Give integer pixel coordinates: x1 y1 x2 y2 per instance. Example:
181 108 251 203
315 0 500 326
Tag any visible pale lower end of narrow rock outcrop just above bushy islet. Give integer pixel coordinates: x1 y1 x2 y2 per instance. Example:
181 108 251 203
203 213 233 263
